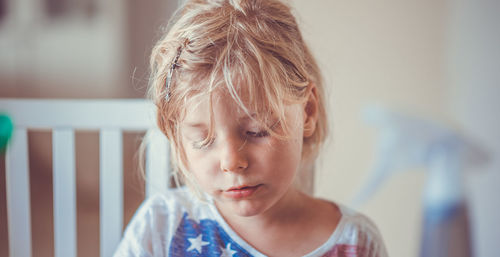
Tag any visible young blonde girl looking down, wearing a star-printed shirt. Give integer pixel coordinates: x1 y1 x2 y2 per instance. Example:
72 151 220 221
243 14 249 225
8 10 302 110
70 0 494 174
115 0 387 257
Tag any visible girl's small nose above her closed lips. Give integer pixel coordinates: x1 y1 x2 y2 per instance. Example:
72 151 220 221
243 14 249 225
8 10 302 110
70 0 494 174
220 136 248 172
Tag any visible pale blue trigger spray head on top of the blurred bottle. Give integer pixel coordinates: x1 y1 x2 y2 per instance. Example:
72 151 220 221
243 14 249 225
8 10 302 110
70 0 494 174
352 106 488 206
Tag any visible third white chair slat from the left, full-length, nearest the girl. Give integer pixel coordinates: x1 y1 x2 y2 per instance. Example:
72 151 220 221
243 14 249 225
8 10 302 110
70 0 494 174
99 129 123 257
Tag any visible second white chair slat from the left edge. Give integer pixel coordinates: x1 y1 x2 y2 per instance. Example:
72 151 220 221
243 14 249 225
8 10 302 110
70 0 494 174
52 129 77 257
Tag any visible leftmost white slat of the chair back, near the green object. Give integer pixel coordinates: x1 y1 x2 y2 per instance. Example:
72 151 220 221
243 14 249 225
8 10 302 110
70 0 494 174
5 128 31 257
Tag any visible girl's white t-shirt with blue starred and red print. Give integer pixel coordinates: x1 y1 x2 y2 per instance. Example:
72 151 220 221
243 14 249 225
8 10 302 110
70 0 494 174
114 187 387 257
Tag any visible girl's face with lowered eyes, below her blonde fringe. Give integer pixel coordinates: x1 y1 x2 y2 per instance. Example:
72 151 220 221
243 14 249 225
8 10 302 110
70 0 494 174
181 92 304 216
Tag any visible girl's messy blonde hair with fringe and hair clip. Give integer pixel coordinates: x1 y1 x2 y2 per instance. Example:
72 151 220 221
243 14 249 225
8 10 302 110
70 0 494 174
149 0 328 191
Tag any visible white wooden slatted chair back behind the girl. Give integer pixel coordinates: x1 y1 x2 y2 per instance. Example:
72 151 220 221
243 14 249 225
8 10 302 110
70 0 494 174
0 99 170 257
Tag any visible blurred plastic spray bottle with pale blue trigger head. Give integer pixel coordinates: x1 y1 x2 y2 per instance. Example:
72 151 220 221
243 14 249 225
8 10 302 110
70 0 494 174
352 107 487 257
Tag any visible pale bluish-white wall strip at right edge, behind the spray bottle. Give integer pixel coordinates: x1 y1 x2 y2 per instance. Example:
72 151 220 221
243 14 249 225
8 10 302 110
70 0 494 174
447 0 500 254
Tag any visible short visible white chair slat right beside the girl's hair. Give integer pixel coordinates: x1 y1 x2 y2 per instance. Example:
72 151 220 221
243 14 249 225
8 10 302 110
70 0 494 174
146 129 170 197
